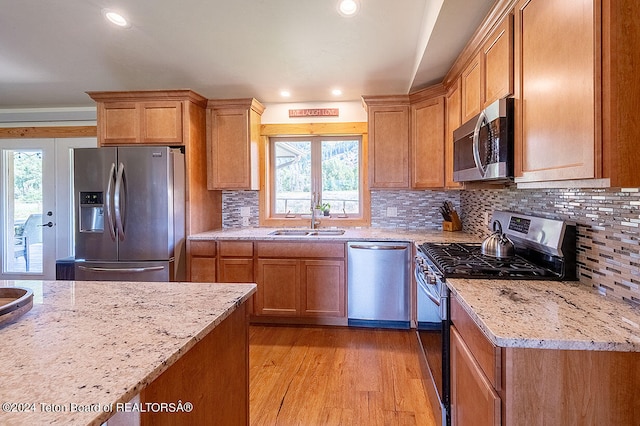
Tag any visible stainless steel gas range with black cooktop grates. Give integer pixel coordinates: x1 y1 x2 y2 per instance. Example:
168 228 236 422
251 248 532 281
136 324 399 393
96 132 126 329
415 211 576 425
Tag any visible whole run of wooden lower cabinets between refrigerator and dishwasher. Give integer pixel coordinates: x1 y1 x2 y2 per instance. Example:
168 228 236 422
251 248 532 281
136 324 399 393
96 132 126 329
187 240 347 325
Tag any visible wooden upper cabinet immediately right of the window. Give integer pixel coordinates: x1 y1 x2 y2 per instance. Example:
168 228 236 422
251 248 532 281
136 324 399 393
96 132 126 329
362 95 410 189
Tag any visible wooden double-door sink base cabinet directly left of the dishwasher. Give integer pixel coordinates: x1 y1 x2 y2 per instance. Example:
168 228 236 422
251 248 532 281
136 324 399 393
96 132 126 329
254 241 346 325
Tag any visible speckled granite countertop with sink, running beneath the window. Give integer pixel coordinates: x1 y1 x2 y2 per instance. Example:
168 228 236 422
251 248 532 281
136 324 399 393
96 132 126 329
189 227 482 244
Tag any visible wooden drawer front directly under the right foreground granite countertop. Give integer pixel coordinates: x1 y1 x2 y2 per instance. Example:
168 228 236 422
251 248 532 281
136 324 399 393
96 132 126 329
451 295 502 390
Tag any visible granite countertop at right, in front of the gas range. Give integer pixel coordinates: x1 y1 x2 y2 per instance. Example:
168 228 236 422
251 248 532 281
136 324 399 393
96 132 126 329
447 278 640 352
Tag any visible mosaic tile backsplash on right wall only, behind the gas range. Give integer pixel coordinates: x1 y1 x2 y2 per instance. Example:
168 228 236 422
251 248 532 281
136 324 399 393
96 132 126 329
460 186 640 306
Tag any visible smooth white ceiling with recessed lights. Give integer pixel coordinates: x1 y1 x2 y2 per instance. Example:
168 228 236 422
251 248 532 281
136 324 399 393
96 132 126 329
0 0 494 109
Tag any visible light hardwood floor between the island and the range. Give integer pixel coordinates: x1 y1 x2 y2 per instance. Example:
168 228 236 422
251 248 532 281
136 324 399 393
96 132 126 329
249 325 435 426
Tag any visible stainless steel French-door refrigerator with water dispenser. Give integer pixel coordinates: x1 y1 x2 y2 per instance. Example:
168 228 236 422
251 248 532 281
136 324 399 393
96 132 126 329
73 146 185 281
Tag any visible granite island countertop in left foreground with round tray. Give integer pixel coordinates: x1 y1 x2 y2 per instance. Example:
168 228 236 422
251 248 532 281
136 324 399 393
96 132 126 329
0 281 256 425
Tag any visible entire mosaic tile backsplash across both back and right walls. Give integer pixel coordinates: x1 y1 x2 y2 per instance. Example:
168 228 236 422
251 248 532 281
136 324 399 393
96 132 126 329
222 185 640 307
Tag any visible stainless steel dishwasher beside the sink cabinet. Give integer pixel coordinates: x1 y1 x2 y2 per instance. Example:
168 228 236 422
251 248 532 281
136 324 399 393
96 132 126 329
347 241 412 328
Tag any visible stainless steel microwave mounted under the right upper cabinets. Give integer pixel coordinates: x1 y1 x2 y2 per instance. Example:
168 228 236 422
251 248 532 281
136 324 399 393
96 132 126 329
453 98 513 182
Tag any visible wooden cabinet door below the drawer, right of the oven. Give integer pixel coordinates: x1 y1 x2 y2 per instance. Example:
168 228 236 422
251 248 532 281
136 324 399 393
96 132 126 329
451 327 500 426
